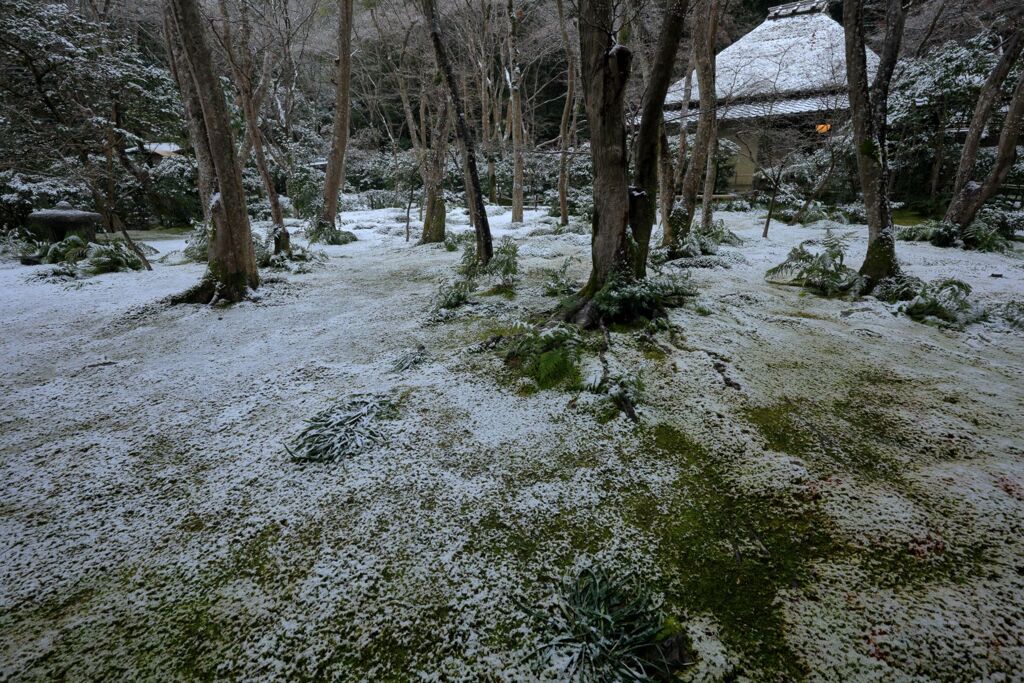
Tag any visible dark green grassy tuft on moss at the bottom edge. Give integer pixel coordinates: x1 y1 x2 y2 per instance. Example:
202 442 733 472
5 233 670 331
542 568 684 683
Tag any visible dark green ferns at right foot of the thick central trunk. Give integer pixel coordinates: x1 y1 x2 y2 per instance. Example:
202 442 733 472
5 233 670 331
594 273 697 323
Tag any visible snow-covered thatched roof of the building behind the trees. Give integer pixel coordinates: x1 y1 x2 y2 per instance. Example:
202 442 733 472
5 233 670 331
666 0 879 105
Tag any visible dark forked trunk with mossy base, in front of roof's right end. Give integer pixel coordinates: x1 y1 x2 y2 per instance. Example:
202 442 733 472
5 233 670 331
843 0 906 291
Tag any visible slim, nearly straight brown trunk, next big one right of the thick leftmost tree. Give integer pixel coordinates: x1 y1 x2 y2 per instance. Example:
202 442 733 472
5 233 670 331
318 0 352 233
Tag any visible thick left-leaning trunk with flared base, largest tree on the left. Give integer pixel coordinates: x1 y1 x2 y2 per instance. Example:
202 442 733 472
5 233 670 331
168 0 259 301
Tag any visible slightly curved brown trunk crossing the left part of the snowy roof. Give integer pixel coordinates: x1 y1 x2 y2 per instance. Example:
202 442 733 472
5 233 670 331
663 0 719 250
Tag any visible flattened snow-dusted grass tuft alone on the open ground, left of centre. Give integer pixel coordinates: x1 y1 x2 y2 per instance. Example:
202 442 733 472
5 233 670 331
285 394 397 463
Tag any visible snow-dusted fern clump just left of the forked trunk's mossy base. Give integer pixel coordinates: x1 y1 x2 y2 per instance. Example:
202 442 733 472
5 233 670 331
765 230 859 296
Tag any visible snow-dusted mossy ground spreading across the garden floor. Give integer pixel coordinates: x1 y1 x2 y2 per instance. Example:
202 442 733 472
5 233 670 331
0 209 1024 681
